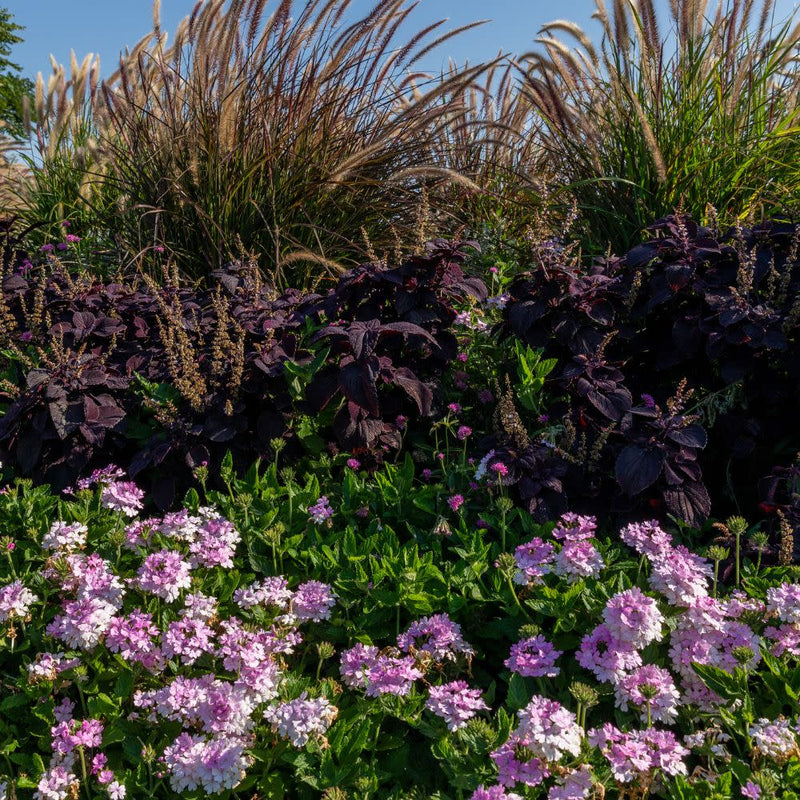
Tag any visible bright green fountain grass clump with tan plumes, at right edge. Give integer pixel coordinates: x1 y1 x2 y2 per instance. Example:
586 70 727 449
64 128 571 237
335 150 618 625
520 0 800 251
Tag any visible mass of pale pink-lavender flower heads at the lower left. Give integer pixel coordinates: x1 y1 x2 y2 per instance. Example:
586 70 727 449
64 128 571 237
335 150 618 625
0 478 338 800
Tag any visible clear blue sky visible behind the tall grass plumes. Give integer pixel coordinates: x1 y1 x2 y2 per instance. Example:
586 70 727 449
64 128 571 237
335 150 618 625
6 0 798 77
